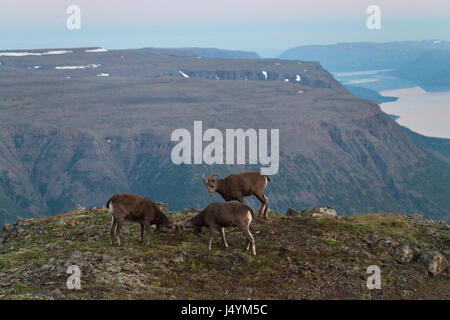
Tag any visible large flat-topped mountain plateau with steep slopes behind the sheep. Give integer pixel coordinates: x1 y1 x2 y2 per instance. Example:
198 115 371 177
0 49 450 223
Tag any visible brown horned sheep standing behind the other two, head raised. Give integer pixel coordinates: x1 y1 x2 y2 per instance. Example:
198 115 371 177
202 171 270 219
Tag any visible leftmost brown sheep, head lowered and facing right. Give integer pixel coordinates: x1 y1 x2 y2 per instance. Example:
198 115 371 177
106 193 178 246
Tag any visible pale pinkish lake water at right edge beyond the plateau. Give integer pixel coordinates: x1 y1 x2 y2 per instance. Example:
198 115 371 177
380 87 450 138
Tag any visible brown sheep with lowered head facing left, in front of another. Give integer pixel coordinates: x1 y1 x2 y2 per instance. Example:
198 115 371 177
190 201 256 255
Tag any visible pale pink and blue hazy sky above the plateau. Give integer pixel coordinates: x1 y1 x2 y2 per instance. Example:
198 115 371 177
0 0 450 56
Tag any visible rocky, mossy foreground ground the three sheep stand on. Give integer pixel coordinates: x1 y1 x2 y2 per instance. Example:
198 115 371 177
0 208 450 299
